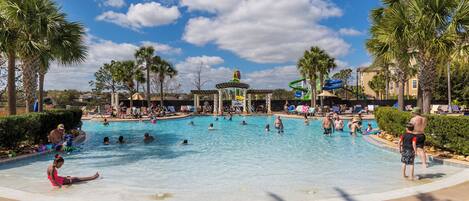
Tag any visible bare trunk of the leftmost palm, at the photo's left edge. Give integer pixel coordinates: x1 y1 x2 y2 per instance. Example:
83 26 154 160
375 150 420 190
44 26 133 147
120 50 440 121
7 50 16 115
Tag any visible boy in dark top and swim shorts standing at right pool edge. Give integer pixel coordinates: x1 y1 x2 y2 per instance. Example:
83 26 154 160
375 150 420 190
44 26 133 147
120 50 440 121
399 123 417 180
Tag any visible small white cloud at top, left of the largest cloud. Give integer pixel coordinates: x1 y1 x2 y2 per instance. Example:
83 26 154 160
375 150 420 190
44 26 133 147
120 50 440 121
96 2 181 30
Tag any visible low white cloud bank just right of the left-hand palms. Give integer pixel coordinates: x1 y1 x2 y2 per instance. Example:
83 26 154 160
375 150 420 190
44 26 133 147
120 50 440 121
45 35 181 90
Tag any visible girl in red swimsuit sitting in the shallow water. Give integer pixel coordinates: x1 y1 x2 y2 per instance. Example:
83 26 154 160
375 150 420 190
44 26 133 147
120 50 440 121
47 154 99 188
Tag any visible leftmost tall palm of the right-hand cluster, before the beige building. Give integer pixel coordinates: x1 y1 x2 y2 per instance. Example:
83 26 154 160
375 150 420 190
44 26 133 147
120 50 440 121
366 0 412 111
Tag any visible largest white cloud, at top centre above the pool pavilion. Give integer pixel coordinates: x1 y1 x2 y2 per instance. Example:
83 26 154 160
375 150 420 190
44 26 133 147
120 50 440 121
181 0 350 63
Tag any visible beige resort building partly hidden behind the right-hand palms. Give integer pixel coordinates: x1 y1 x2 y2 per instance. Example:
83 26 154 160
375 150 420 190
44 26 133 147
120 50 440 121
357 66 418 99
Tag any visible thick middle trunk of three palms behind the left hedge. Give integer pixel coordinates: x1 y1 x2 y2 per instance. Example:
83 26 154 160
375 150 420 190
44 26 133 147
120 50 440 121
22 58 38 113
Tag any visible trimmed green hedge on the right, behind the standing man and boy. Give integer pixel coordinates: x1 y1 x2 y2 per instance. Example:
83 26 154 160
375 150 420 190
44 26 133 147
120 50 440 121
375 107 469 155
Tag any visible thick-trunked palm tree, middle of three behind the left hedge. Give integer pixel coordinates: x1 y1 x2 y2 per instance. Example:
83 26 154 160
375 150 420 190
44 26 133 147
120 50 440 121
0 0 78 112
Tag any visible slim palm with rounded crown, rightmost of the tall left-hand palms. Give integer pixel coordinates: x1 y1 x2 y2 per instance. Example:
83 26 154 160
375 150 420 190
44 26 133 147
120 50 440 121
38 19 86 112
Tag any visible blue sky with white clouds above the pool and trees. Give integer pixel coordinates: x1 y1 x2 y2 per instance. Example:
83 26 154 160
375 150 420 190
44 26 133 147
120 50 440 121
45 0 379 91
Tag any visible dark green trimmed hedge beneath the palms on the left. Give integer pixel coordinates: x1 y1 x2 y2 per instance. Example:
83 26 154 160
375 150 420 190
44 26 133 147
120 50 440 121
0 110 82 148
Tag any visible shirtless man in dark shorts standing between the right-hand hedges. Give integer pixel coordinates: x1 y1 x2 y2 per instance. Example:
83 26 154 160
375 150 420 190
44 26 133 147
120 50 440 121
410 107 427 168
